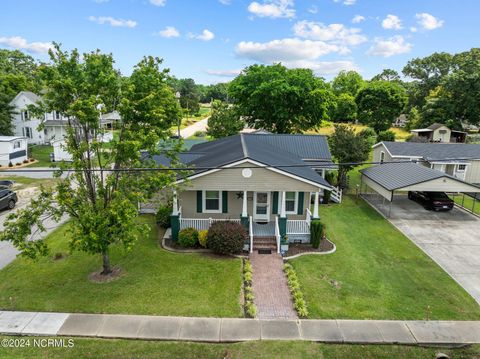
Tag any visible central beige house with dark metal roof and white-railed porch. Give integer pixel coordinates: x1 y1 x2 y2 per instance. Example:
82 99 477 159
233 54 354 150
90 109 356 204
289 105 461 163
150 134 335 252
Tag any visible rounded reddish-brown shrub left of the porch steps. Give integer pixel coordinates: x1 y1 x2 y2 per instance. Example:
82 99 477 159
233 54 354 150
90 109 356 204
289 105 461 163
207 221 247 255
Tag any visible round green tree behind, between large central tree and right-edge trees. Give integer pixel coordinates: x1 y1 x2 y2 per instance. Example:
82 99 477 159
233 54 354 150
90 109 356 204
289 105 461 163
356 81 407 134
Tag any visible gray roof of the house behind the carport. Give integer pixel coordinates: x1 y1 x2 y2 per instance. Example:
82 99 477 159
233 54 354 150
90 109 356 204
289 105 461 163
383 141 480 161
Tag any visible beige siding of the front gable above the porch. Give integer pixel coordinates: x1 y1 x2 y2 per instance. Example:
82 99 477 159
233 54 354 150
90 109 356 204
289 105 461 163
186 163 319 192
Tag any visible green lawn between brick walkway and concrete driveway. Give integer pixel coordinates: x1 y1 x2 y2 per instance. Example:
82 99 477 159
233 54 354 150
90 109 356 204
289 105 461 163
292 196 480 320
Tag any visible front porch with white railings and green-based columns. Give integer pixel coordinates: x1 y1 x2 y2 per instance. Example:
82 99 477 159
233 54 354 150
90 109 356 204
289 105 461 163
172 191 321 253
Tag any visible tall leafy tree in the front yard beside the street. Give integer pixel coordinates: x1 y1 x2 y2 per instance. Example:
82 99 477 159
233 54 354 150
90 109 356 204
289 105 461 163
0 46 179 275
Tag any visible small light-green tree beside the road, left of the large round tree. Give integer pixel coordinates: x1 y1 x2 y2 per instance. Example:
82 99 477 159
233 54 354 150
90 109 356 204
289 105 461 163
207 100 245 138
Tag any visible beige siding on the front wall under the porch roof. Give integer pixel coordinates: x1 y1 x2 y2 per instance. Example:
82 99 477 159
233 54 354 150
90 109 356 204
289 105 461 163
178 191 310 221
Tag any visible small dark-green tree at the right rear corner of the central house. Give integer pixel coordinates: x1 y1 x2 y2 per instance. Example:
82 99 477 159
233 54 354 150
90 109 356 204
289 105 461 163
328 124 370 188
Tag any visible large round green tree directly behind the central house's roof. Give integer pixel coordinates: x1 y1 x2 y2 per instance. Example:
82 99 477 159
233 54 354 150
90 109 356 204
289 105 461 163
229 64 335 133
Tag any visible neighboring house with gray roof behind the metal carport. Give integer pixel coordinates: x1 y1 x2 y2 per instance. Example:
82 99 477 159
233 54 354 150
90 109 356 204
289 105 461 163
373 141 480 184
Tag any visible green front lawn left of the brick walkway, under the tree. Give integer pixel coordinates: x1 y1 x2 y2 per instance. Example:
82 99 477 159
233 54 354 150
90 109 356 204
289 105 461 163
0 216 241 317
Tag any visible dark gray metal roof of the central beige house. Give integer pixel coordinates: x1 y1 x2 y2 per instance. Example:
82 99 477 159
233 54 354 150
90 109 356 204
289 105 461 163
154 134 331 188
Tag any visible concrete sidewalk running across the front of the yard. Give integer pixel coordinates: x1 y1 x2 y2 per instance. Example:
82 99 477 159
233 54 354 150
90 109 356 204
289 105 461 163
0 311 480 345
